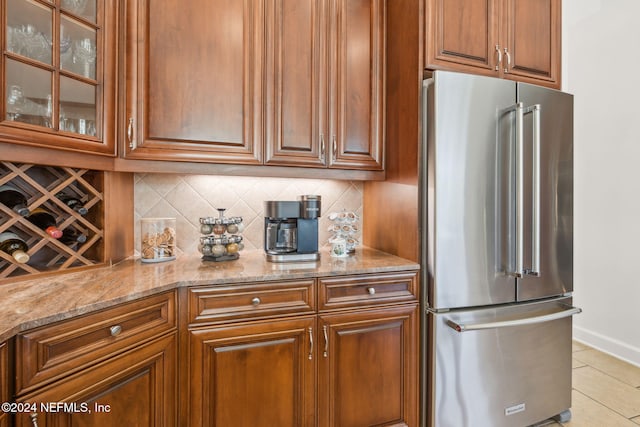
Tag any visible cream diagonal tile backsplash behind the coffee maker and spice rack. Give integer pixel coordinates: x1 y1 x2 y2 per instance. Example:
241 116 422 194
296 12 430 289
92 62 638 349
134 174 363 253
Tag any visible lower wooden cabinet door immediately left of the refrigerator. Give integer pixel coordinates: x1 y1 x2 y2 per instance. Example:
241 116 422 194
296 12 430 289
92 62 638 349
318 304 419 427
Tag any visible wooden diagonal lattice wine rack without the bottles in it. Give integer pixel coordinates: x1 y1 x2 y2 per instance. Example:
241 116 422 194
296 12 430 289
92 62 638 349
0 162 104 283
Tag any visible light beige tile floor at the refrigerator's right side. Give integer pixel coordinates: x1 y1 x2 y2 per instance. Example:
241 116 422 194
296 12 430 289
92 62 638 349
543 341 640 427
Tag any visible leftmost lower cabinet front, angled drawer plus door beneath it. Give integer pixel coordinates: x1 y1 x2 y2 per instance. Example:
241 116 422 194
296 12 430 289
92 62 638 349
16 292 178 427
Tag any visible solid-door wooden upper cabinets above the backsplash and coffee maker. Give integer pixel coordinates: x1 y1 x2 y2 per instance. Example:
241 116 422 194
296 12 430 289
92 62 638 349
121 0 385 171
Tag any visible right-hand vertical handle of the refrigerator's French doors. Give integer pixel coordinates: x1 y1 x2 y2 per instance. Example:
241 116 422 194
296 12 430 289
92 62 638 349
524 104 541 276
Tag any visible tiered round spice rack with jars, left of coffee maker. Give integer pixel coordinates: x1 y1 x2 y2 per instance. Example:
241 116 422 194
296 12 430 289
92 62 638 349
198 208 244 261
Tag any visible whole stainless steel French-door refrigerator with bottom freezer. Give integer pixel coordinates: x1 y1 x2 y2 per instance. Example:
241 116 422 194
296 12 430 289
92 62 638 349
421 71 580 427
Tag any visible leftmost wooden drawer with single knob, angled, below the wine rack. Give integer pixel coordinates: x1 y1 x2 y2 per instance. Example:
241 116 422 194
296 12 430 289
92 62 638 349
16 291 176 395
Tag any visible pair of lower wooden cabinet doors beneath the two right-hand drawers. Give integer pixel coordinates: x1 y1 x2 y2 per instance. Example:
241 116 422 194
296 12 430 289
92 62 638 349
189 304 419 427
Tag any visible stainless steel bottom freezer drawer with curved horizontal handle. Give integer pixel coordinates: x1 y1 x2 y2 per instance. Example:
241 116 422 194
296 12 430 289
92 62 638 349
427 297 580 427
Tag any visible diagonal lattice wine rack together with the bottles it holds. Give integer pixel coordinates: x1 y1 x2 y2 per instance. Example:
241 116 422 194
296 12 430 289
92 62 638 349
0 162 102 280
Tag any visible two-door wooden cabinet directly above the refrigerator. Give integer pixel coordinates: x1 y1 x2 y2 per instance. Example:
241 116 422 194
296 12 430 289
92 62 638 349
425 0 561 88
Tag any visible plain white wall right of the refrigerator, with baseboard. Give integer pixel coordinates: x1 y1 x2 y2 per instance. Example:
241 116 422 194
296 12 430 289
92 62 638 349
563 0 640 365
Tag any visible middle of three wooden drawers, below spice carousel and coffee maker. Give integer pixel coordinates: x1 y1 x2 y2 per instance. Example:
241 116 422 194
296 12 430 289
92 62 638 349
189 279 315 323
